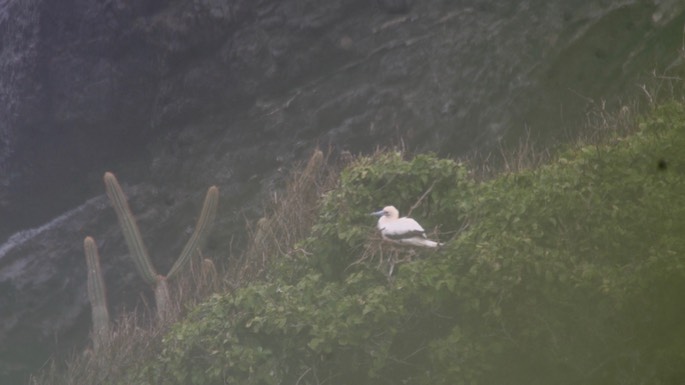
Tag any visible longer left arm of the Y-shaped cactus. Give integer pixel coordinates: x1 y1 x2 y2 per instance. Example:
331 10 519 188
103 172 157 286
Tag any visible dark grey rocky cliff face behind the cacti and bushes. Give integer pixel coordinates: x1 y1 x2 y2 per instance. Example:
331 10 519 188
0 0 683 378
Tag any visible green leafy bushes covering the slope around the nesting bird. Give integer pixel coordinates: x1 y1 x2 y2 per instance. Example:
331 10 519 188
36 104 685 385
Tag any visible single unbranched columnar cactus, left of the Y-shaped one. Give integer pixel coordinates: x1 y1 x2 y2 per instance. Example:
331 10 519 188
83 237 109 352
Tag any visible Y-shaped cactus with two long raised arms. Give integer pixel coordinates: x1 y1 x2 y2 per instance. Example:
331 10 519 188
103 172 219 320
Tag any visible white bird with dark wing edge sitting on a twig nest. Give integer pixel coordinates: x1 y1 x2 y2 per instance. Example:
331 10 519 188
371 206 443 248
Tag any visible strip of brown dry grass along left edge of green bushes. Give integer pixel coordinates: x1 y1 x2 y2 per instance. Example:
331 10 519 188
29 149 342 385
